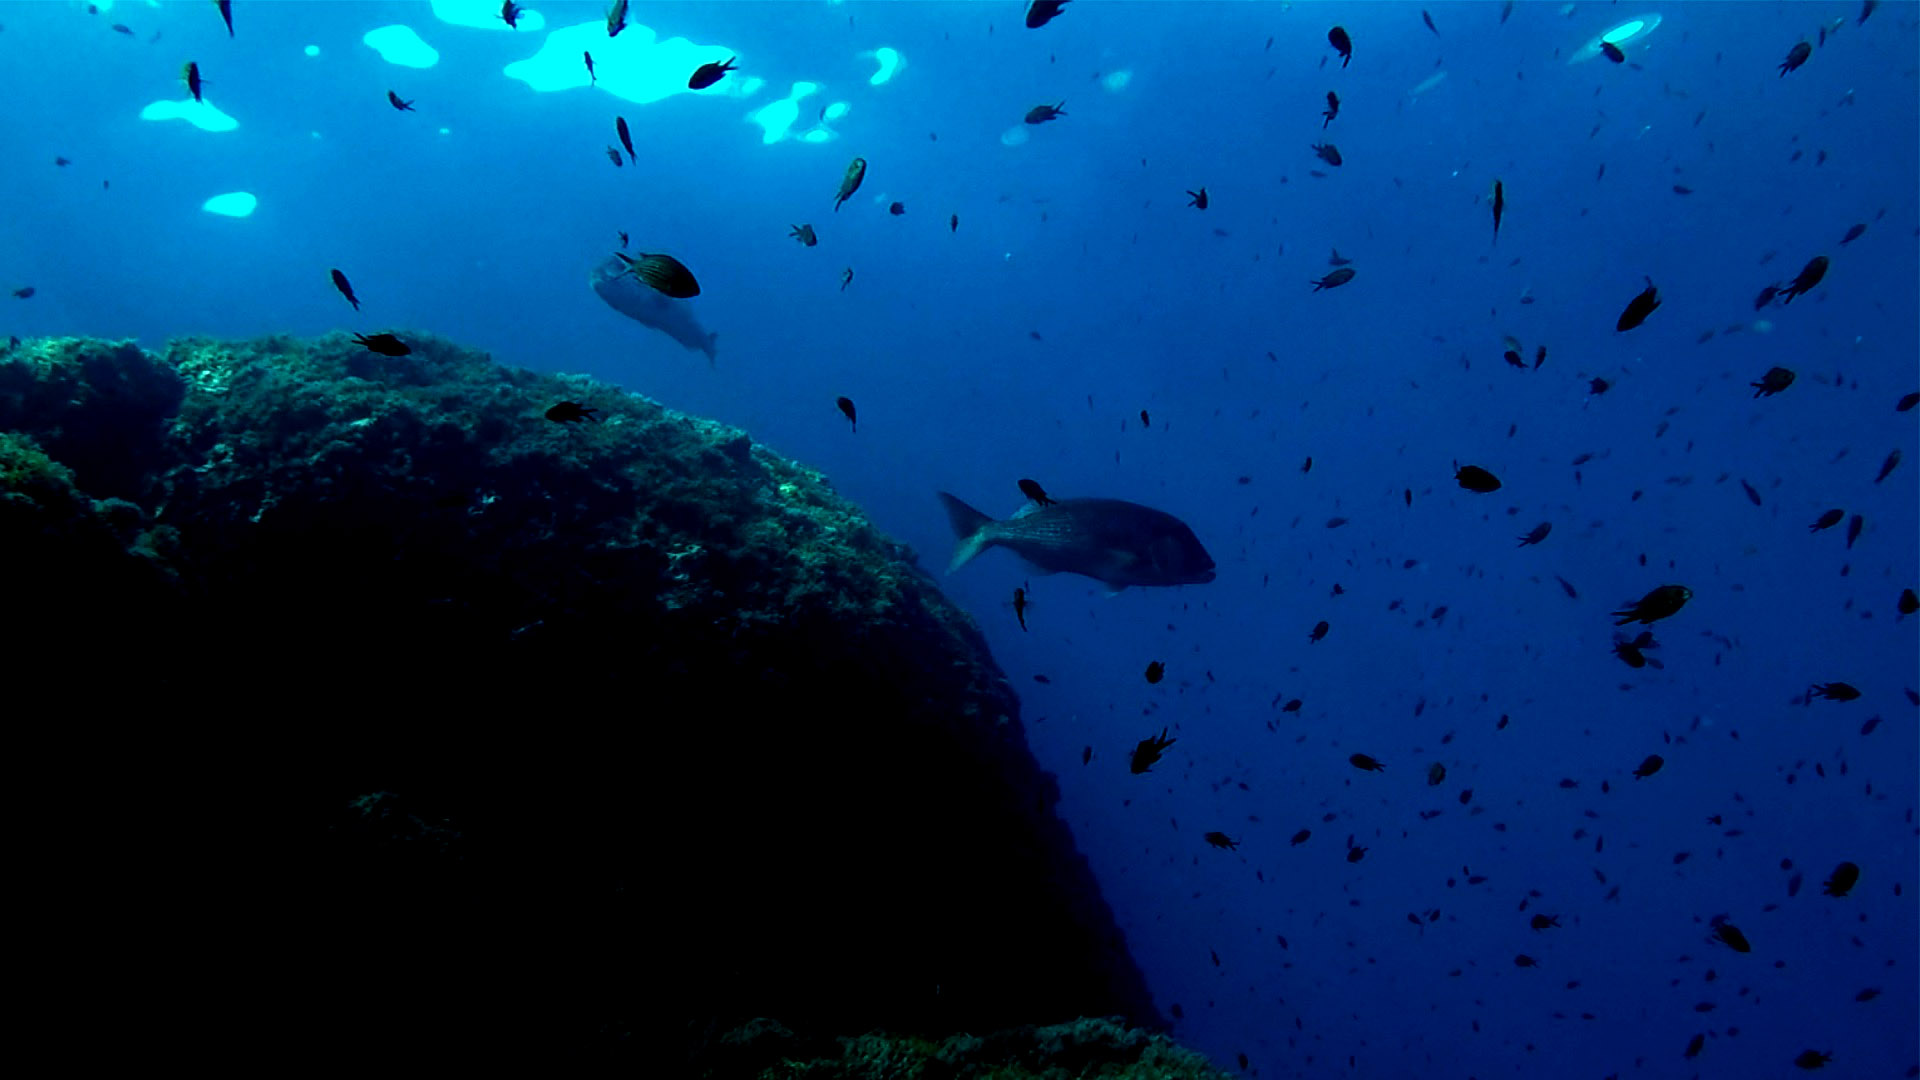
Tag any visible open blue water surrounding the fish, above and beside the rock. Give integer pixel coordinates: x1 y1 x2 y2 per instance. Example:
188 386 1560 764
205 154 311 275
0 0 1920 1076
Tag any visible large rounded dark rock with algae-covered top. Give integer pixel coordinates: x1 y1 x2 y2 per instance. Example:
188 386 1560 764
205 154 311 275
0 332 1158 1074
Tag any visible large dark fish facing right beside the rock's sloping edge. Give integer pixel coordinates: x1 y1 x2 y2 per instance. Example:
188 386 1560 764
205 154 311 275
939 492 1213 592
